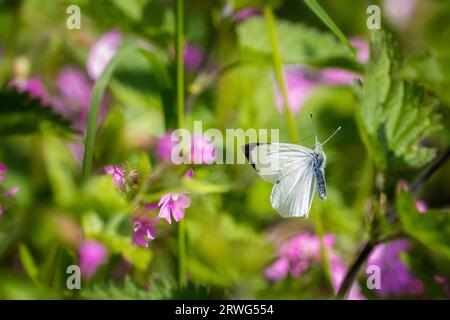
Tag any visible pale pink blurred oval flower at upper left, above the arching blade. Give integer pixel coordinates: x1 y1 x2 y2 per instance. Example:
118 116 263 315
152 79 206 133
86 30 122 80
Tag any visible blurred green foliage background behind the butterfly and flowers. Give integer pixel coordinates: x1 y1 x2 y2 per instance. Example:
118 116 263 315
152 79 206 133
0 0 450 299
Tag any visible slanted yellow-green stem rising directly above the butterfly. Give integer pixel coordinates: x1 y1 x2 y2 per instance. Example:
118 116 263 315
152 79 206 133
264 6 299 143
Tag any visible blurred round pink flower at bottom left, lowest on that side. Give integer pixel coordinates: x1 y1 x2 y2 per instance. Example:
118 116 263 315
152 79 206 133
79 240 108 279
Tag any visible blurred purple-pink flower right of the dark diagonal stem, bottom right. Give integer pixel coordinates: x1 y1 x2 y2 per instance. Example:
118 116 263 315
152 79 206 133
367 240 424 296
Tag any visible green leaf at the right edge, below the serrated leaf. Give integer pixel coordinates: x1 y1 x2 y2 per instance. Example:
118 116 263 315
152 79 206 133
397 190 450 259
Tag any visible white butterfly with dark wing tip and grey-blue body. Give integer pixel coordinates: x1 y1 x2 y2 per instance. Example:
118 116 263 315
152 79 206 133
244 127 341 217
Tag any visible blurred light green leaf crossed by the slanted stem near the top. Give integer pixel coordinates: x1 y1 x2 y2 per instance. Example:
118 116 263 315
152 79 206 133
237 17 358 70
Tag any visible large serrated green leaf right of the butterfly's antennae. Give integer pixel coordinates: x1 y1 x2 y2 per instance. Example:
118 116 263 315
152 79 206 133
355 31 442 170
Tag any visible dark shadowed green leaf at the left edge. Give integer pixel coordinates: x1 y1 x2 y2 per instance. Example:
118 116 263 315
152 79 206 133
0 90 72 138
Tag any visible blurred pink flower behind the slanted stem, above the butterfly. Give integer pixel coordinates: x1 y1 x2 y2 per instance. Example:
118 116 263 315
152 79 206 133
275 67 316 115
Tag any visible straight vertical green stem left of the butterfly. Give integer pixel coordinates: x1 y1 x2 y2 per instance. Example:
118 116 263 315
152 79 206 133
175 0 186 288
